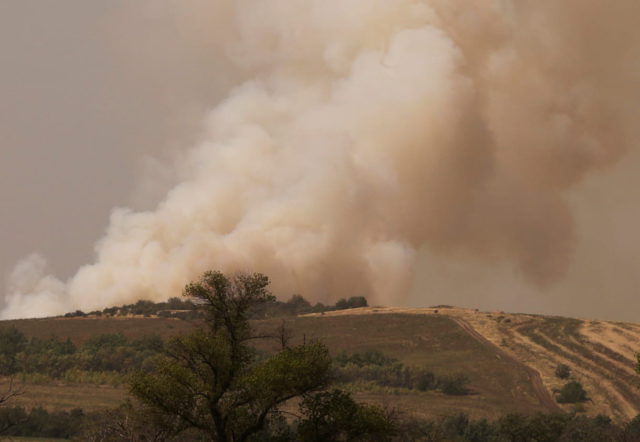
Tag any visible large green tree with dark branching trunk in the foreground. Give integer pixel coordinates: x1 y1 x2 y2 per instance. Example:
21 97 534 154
131 272 331 442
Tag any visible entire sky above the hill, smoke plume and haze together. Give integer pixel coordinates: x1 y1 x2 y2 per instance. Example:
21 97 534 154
0 0 640 320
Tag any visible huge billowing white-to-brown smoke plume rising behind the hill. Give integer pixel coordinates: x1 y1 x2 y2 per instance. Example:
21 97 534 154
2 0 640 318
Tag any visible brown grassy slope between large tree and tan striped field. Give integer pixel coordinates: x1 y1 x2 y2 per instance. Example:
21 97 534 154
255 309 557 418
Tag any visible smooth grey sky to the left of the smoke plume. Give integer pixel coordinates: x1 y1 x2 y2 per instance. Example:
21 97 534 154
0 0 229 277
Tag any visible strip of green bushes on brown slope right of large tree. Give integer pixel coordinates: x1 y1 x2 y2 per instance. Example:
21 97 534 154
334 350 471 395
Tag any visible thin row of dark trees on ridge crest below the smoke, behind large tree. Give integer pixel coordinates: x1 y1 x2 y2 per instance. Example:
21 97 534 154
64 295 368 319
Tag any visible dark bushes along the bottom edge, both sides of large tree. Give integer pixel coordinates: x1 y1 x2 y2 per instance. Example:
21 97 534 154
0 408 640 442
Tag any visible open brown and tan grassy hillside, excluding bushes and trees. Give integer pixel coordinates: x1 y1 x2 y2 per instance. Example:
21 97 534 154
0 307 640 419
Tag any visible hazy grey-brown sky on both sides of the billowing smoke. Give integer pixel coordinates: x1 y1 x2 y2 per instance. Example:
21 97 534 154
0 0 640 320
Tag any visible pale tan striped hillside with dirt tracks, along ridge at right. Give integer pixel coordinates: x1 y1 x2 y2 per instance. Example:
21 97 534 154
304 308 640 420
